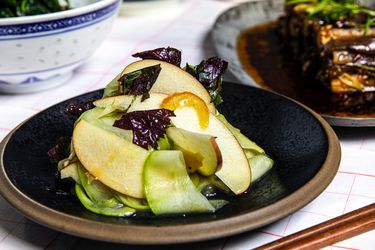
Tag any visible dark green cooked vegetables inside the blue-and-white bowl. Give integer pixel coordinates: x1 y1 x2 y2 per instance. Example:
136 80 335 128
0 0 70 18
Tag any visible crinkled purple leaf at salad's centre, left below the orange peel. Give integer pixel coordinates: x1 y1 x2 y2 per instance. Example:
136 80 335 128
113 109 175 149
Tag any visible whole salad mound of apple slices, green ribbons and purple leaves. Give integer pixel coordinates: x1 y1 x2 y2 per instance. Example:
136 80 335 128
59 48 273 216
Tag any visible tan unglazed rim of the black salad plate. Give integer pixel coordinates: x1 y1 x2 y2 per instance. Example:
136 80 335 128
0 87 341 244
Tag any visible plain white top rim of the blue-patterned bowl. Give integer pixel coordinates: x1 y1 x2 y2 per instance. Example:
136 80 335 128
0 0 121 26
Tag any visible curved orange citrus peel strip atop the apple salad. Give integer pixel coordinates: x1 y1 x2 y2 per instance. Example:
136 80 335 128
161 92 210 128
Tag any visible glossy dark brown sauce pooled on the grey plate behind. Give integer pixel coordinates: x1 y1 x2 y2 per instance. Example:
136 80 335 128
237 22 375 118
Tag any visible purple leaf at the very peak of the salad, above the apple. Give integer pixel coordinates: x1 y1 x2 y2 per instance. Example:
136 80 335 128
133 47 181 67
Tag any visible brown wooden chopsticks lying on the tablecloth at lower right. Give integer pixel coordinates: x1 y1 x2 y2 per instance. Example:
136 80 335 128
256 203 375 250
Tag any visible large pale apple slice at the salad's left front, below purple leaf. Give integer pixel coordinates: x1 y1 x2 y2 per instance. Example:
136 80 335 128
72 120 149 198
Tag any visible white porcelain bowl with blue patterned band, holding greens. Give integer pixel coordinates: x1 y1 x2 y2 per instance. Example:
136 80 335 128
0 0 121 93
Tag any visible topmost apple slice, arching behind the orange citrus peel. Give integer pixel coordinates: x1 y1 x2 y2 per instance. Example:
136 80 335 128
119 59 216 114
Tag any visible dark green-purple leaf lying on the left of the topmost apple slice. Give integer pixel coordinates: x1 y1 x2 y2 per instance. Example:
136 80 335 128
118 64 161 100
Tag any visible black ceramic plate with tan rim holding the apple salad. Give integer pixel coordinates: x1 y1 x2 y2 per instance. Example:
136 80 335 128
0 83 340 244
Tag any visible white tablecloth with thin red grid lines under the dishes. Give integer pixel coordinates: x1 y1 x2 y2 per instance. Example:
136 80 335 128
0 0 375 250
